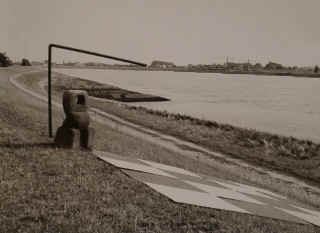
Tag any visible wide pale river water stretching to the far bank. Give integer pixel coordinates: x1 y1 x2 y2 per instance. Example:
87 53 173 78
56 69 320 142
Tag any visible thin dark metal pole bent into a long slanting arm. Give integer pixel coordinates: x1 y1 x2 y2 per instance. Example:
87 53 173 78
48 44 147 137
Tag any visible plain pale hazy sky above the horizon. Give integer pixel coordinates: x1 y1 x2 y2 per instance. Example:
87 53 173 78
0 0 320 66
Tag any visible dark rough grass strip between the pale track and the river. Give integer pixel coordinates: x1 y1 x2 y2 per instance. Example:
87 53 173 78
110 103 320 177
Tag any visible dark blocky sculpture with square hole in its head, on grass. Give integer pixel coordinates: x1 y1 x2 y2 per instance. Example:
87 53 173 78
55 90 95 150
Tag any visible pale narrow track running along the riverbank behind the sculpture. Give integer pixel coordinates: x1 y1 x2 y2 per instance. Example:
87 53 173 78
10 68 320 201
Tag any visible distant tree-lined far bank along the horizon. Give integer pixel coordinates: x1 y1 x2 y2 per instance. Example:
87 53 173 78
0 53 320 78
